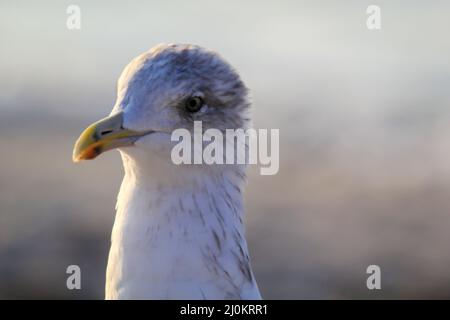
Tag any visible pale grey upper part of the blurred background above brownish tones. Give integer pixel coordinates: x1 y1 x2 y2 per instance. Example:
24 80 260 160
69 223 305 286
0 1 450 121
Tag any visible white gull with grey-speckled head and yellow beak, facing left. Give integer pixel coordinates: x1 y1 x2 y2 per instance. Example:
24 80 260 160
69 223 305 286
73 44 261 300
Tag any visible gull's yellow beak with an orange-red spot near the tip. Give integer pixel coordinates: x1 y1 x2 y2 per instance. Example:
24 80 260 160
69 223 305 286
72 112 150 162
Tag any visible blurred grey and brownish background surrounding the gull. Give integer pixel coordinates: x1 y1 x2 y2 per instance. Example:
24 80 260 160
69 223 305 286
0 0 450 299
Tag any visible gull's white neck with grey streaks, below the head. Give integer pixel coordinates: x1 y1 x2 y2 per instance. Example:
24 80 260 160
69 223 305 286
107 156 260 299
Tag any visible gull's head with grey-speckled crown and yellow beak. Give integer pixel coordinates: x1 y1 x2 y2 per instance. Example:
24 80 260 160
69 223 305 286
73 44 250 176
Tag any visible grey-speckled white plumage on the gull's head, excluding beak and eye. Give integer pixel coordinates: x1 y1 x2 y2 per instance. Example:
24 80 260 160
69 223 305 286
113 44 250 130
